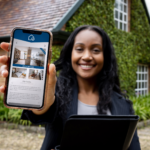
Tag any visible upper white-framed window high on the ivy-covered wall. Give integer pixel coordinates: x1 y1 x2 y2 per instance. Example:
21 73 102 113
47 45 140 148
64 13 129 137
114 0 128 31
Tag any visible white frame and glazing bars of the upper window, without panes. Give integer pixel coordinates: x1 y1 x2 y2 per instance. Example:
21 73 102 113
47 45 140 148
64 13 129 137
114 0 128 32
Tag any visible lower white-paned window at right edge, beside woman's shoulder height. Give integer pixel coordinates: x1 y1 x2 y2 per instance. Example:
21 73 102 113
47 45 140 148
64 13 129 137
135 65 148 96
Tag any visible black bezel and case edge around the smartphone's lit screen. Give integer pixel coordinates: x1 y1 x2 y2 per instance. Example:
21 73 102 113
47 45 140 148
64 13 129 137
4 27 53 110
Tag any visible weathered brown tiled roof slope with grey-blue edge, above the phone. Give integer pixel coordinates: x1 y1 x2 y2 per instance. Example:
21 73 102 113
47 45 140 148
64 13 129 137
0 0 84 38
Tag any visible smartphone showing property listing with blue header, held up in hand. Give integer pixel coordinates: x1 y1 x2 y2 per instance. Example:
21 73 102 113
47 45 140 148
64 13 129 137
4 27 52 109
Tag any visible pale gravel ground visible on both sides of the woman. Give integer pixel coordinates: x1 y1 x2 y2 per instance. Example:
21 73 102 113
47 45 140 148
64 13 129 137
0 127 150 150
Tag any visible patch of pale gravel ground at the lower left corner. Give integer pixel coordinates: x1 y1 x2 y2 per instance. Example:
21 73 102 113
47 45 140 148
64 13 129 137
0 128 44 150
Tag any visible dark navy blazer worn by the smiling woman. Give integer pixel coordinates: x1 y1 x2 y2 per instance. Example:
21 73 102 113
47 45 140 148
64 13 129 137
21 86 141 150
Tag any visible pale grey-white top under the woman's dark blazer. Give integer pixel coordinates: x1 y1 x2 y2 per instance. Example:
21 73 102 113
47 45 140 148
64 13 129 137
77 100 111 115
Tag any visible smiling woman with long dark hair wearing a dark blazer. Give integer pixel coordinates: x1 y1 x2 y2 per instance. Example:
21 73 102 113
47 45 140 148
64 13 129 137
0 26 140 150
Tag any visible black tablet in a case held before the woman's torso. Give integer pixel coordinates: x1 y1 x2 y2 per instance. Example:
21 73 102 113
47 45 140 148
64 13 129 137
60 115 139 150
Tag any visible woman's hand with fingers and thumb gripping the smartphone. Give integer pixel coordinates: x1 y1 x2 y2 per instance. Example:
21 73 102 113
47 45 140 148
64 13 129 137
0 42 57 115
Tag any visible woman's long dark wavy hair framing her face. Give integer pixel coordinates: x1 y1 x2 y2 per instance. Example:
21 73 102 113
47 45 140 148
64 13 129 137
54 25 132 116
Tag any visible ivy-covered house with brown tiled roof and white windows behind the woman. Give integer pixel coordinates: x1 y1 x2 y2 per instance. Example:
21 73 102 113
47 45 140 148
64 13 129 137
0 0 150 95
